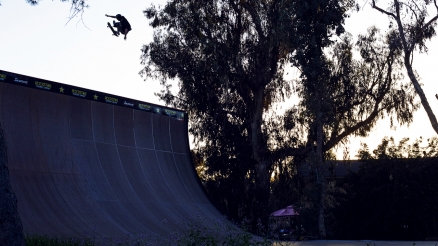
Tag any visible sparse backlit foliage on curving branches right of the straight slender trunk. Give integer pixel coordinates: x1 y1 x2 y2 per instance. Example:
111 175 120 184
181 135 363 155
318 27 419 150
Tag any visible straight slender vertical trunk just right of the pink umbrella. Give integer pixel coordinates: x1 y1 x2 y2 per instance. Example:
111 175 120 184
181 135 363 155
316 92 327 239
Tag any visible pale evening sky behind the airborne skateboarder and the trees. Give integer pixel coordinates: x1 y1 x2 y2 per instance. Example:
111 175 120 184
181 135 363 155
0 0 438 159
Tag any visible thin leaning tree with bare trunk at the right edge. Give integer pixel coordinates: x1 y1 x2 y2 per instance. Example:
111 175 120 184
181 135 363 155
371 0 438 133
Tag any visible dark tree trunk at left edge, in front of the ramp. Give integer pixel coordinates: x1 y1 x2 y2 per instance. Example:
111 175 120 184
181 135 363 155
0 124 24 246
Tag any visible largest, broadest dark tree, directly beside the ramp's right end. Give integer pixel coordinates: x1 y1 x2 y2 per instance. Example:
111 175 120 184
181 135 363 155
141 0 300 225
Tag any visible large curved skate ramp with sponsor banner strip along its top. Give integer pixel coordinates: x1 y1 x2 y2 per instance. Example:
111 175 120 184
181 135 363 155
0 71 224 238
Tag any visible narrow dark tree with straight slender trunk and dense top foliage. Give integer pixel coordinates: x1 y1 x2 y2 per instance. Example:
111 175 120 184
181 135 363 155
292 0 353 238
